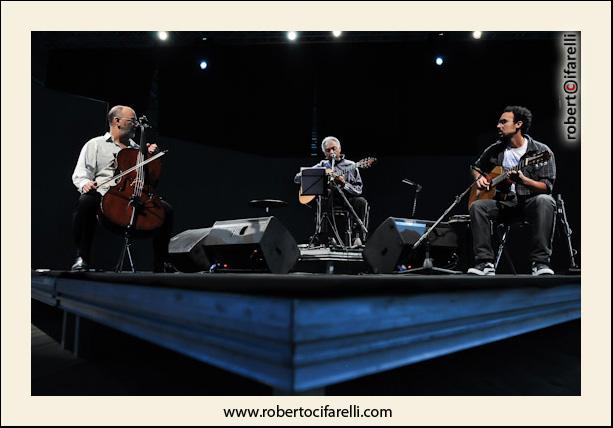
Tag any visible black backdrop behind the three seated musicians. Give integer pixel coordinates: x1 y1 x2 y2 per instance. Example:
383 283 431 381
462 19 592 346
31 33 580 269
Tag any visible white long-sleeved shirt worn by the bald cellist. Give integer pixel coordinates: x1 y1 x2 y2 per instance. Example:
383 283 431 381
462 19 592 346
72 132 138 195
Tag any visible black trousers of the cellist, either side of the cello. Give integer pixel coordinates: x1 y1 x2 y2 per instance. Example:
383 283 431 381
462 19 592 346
72 192 174 272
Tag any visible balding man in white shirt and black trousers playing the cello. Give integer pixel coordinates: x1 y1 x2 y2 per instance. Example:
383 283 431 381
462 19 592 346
71 105 173 272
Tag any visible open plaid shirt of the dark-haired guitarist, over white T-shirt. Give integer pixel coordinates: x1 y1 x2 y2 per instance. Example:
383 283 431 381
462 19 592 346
475 135 556 197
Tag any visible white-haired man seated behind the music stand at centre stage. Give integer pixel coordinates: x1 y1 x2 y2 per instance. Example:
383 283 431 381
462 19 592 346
294 137 374 243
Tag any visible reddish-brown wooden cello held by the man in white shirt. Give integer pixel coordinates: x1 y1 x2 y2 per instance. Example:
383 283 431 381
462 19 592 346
98 116 167 234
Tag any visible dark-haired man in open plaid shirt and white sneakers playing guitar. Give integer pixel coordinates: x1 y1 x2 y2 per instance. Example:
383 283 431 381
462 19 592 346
468 106 556 275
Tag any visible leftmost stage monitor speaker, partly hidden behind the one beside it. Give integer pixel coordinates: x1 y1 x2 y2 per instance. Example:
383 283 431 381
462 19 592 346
168 227 212 272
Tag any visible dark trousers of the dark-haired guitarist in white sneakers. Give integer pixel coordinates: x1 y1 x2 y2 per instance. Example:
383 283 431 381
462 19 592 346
469 194 556 264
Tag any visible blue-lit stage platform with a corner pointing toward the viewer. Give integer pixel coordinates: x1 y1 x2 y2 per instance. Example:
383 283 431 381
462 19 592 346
32 271 581 394
